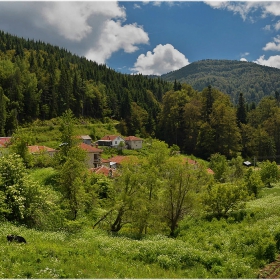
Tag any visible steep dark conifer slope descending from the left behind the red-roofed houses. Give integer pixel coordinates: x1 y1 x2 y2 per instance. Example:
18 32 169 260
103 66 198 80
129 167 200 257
0 31 173 136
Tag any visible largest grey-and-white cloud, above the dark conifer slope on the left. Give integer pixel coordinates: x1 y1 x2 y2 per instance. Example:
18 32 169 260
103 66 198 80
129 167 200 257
0 1 149 63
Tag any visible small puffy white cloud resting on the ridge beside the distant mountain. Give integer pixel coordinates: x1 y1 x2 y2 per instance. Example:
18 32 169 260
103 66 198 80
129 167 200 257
130 44 189 75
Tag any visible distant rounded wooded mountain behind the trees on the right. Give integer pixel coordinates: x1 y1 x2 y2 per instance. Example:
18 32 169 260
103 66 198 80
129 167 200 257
161 59 280 103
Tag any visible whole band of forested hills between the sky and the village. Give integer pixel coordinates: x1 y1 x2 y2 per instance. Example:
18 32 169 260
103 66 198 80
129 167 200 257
0 32 280 160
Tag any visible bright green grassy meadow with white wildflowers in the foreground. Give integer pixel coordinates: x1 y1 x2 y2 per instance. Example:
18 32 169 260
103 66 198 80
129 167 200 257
0 185 280 278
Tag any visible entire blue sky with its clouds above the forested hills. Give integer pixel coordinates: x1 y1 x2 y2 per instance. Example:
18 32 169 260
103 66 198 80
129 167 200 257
0 1 280 75
